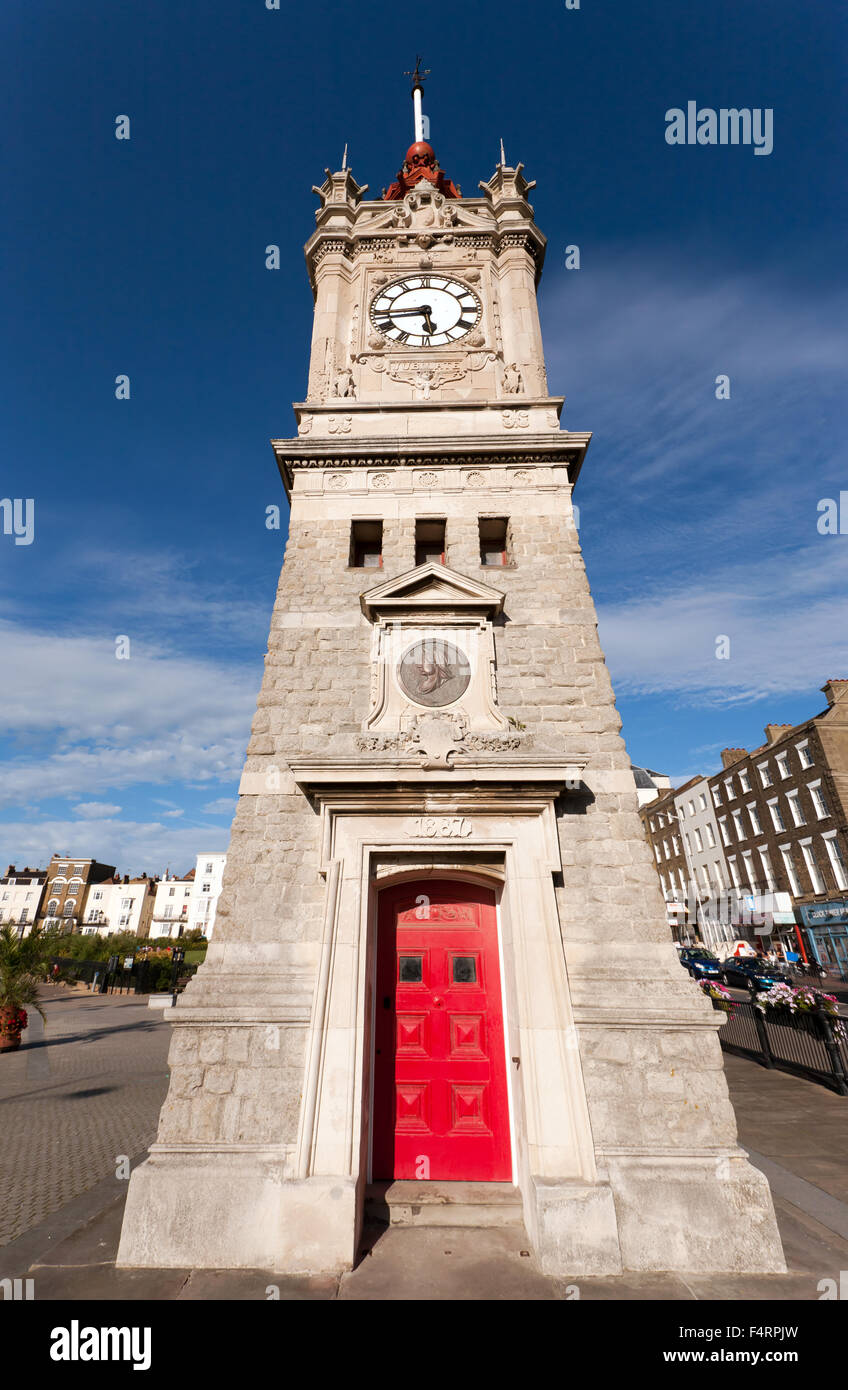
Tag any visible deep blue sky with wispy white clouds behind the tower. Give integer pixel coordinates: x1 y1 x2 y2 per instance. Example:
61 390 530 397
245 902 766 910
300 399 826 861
0 0 848 873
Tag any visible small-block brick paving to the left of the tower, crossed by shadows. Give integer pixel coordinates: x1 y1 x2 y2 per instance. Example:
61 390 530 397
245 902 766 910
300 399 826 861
0 986 171 1247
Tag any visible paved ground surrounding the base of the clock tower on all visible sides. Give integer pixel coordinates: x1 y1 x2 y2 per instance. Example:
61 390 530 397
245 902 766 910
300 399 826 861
0 991 848 1302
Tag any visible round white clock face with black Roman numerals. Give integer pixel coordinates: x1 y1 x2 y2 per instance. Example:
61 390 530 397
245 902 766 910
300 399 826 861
371 275 482 348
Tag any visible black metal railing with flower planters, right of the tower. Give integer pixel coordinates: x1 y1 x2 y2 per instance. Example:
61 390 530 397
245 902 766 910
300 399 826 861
713 999 848 1095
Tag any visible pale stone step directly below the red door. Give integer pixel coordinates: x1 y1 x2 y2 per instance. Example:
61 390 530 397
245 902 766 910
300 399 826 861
366 1182 524 1226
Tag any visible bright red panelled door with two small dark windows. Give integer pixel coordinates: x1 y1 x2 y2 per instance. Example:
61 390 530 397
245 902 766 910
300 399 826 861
373 880 512 1183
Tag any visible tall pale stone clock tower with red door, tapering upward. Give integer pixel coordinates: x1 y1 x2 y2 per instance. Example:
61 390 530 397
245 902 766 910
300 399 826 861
118 92 784 1276
